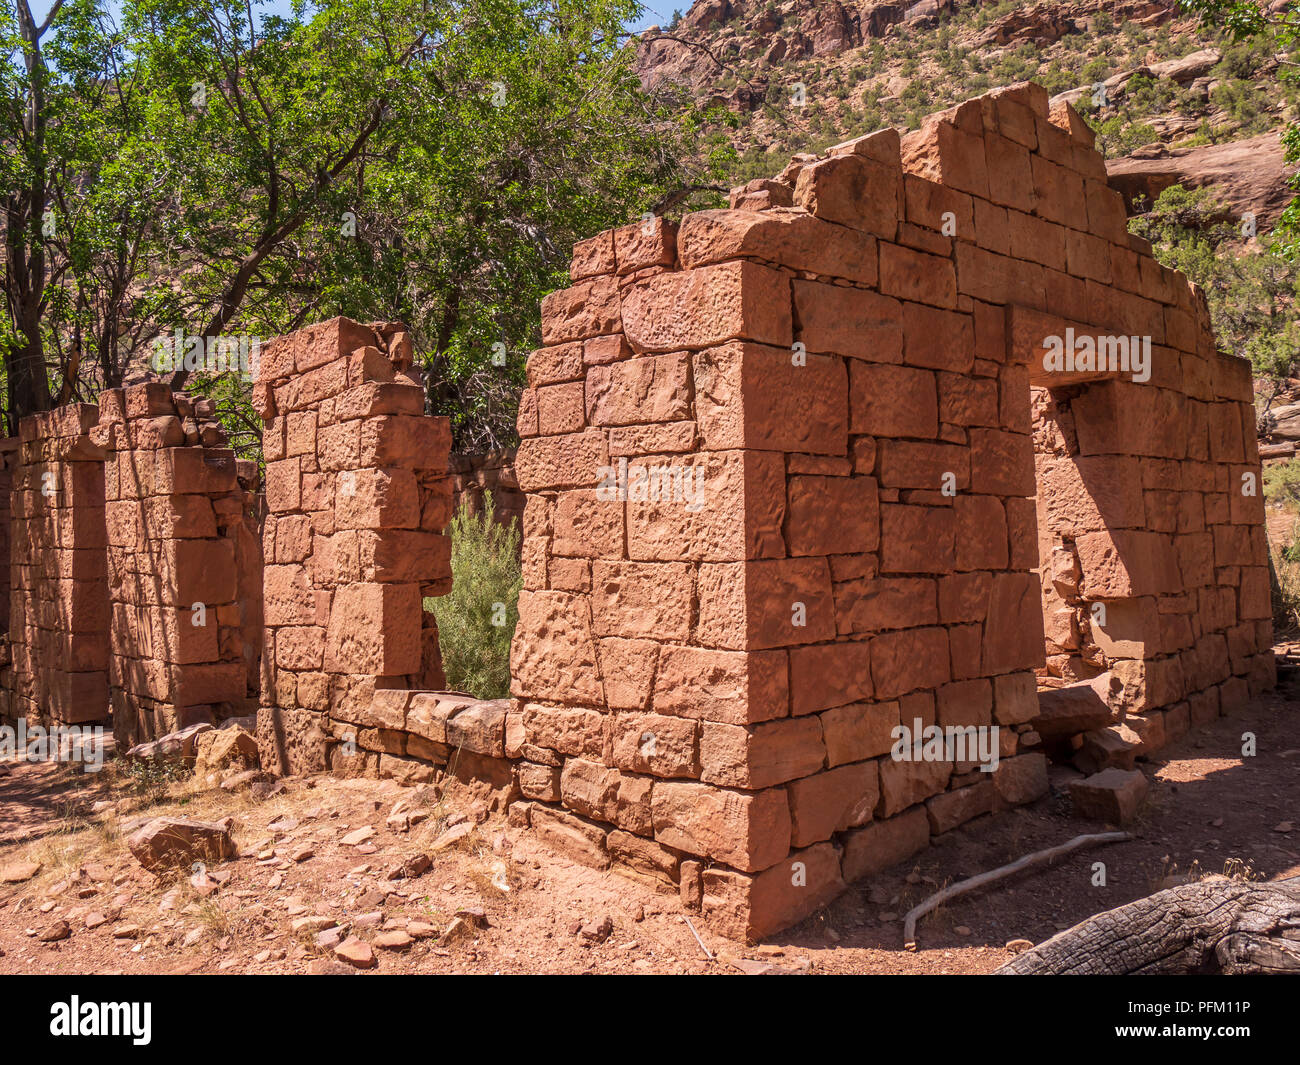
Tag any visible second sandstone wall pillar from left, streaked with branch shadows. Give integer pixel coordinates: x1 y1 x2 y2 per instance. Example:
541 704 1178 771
94 382 261 746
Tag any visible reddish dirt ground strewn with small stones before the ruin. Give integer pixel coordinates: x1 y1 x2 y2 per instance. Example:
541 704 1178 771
0 689 1300 974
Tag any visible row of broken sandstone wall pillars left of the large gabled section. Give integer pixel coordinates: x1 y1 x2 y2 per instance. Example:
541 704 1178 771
0 325 521 796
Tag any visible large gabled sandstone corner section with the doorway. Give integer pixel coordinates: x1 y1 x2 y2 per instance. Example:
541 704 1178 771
506 85 1273 938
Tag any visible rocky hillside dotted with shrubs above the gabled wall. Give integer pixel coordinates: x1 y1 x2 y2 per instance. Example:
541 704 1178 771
637 0 1300 230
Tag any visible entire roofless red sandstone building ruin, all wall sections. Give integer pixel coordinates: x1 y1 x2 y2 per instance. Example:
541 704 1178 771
0 86 1274 938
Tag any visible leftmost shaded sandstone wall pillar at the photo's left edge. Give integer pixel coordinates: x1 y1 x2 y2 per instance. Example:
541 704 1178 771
3 403 109 723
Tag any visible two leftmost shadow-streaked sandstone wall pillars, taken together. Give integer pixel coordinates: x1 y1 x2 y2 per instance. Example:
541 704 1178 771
0 382 261 749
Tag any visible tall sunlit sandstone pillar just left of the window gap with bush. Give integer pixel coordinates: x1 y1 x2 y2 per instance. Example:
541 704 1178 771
254 319 451 778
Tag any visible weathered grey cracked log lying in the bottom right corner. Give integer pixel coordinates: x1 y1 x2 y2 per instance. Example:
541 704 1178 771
996 876 1300 977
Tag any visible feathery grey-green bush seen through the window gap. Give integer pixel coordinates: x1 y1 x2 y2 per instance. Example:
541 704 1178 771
424 492 524 698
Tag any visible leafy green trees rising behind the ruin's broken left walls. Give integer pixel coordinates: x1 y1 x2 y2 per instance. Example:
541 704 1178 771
0 0 725 445
